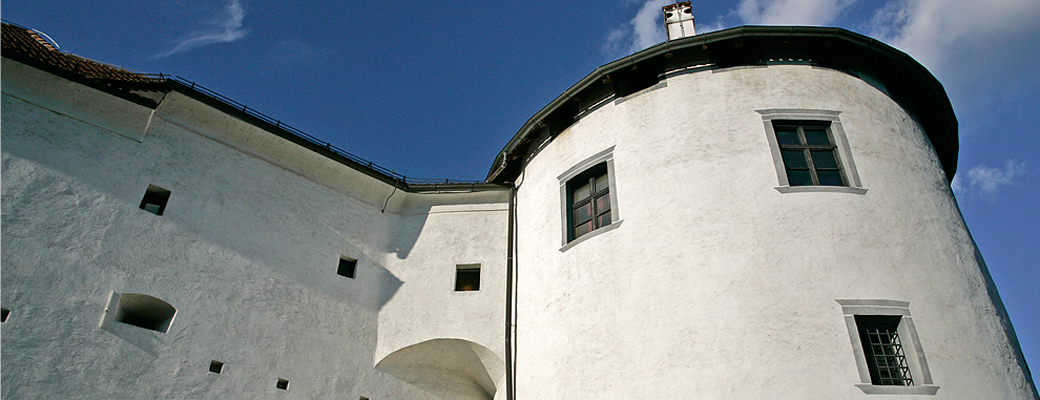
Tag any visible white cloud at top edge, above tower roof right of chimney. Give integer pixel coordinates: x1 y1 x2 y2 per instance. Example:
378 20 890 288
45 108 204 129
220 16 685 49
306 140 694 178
737 0 856 25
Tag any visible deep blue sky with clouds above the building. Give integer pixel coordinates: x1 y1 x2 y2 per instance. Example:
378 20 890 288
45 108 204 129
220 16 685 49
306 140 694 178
0 0 1040 384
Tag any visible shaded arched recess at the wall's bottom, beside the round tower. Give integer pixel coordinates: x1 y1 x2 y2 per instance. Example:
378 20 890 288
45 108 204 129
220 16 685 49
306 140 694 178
375 339 505 400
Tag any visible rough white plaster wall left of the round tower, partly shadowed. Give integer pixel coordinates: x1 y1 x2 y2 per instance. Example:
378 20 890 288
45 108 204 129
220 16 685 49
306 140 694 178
2 59 508 399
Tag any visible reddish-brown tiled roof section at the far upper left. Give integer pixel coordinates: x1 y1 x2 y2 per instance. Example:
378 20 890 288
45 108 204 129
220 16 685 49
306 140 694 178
2 24 168 108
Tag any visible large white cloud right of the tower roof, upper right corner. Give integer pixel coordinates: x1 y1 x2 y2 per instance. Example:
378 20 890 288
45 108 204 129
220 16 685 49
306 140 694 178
868 0 1040 123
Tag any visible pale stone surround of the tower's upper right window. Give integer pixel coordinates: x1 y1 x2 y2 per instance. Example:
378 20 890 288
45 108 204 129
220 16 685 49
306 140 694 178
755 108 866 194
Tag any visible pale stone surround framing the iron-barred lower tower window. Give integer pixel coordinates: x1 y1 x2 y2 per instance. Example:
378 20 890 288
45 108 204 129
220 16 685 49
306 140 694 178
835 299 939 396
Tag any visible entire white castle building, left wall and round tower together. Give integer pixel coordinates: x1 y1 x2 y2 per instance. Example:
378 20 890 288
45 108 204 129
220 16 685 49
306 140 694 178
0 3 1038 400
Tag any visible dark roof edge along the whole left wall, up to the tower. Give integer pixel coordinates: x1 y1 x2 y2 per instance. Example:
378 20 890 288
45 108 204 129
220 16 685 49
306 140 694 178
2 23 506 193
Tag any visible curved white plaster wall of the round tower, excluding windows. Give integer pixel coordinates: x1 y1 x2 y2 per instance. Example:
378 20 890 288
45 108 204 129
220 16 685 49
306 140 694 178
509 64 1033 399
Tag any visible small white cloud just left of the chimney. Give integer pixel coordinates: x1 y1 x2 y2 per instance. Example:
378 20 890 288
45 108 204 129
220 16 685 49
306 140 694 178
603 0 673 58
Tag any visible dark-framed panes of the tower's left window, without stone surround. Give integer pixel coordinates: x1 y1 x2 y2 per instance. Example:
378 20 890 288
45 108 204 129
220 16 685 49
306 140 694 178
567 163 610 240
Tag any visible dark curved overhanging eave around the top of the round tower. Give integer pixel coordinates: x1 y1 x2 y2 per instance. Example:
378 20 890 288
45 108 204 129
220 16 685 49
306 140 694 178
486 26 958 183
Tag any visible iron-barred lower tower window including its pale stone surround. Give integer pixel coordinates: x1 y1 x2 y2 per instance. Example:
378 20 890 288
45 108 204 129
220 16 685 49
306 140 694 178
837 299 939 395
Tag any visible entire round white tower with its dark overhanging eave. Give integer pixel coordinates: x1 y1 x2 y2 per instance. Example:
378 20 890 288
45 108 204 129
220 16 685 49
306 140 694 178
489 27 1036 399
